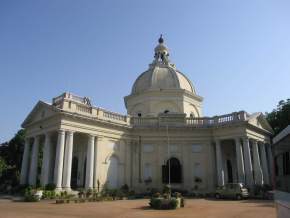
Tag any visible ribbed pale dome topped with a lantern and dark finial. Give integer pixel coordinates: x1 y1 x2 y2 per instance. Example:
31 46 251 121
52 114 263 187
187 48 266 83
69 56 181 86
132 35 195 94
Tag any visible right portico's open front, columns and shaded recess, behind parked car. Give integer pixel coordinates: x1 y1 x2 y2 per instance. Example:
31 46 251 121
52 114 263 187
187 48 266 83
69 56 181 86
215 136 270 187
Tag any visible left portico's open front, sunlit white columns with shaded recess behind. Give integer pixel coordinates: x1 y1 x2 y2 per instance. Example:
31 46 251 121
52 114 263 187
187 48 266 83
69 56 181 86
21 129 103 191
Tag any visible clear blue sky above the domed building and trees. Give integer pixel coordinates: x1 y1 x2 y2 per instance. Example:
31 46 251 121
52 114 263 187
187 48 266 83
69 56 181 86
0 0 290 142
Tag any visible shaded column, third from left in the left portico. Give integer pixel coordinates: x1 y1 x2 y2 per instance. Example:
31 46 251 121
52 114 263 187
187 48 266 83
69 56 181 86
41 132 51 186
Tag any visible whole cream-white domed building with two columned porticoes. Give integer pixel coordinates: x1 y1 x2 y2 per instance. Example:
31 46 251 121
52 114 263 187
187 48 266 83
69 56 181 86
21 37 273 192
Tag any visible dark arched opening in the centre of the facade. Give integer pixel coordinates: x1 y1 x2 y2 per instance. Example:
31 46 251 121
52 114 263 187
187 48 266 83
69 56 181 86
162 157 182 183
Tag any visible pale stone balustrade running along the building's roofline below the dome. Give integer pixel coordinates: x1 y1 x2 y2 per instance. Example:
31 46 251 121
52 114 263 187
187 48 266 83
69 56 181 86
52 93 248 128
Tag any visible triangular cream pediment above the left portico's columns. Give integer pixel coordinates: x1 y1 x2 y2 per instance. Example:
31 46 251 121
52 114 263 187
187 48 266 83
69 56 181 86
21 101 58 128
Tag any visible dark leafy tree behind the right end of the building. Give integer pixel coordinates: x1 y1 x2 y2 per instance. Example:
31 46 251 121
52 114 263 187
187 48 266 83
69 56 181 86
266 98 290 135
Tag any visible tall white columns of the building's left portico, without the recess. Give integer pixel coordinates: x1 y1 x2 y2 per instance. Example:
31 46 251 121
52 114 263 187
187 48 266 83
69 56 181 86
20 129 98 190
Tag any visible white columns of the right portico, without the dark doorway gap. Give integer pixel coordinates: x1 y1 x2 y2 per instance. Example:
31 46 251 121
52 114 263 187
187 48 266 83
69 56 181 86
215 137 273 187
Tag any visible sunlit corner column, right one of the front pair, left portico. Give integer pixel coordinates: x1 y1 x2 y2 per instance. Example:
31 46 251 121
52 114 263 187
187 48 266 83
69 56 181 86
63 131 73 191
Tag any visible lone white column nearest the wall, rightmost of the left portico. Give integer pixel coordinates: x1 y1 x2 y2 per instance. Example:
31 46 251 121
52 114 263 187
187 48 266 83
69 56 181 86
85 135 95 189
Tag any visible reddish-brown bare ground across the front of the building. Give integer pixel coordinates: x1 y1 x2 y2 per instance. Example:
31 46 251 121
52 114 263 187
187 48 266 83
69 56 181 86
0 199 276 218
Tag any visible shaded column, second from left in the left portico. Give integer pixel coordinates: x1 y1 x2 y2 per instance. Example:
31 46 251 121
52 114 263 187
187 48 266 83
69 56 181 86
29 136 40 186
